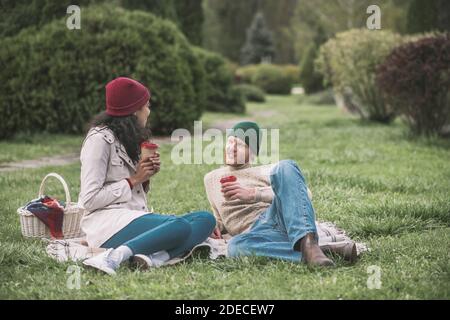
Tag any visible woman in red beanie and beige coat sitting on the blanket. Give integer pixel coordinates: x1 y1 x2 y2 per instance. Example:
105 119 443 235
79 78 216 274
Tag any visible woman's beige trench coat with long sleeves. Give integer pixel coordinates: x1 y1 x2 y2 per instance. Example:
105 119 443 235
78 127 153 247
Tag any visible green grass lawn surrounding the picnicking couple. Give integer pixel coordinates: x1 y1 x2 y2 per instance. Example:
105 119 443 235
0 96 450 299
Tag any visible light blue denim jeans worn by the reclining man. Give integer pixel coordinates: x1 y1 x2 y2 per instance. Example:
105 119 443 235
228 160 318 262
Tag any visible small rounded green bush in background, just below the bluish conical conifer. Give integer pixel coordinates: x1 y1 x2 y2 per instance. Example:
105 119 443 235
251 64 292 94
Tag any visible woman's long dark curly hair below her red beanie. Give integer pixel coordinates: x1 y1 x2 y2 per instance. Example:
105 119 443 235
89 112 151 163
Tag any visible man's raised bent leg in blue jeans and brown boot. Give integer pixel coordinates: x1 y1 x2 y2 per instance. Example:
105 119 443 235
270 160 333 266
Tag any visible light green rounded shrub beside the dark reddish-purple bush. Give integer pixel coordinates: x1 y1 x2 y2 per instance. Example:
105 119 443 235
316 29 402 123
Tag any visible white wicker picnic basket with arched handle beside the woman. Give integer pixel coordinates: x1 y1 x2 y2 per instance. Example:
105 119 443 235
17 173 84 239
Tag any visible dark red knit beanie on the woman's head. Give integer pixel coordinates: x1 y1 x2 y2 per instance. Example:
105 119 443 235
106 77 150 116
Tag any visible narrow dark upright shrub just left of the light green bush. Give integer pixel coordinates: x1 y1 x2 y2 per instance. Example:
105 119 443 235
300 43 323 94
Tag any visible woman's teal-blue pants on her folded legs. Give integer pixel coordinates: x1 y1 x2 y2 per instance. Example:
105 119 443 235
101 211 216 258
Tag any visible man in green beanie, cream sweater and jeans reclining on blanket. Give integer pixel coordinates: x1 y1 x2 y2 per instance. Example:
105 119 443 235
204 122 356 266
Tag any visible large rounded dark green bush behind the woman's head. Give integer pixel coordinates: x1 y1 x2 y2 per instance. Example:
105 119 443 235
0 5 205 137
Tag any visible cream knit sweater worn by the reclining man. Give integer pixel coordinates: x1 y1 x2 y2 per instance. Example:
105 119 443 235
204 164 312 236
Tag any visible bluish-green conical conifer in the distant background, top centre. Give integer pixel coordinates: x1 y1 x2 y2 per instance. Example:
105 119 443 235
241 12 275 65
